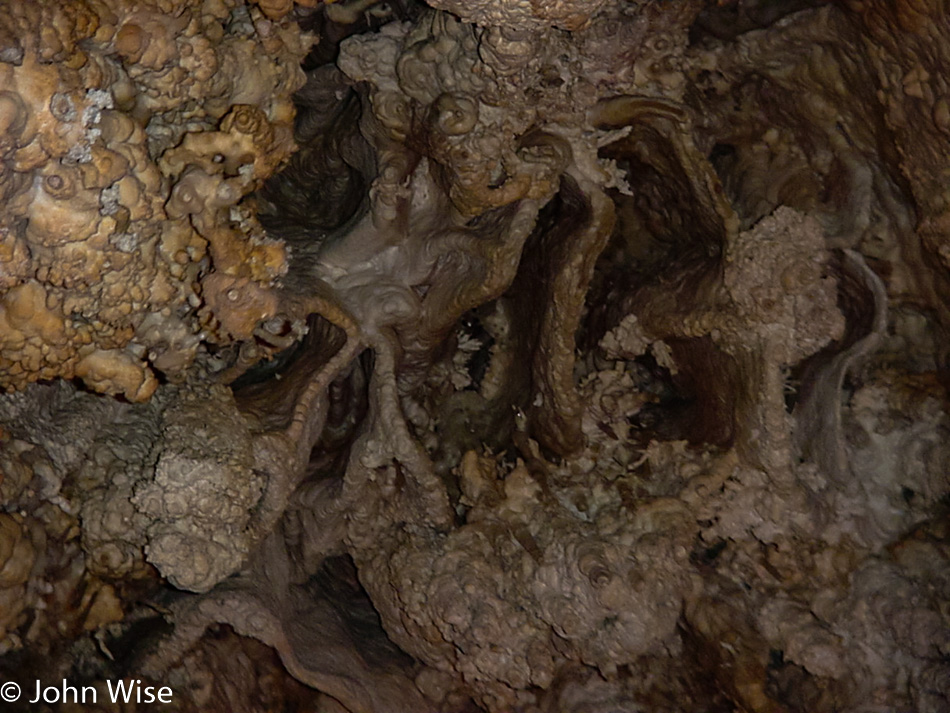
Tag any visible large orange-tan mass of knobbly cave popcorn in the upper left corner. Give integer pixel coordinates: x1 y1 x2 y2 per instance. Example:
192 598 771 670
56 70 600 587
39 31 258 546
0 0 308 401
